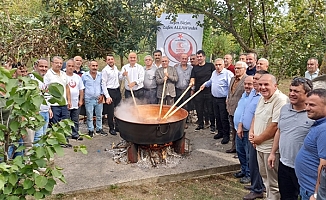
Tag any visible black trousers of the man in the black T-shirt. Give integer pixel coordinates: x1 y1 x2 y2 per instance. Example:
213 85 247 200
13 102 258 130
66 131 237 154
195 93 215 127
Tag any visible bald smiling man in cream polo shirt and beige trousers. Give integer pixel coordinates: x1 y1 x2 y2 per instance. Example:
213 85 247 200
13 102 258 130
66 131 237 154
249 74 289 199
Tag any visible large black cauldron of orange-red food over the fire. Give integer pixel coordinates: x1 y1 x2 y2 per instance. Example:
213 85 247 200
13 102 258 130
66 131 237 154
115 104 188 145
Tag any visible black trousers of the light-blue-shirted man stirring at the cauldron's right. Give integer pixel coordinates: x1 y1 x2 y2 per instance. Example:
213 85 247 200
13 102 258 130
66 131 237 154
213 97 230 138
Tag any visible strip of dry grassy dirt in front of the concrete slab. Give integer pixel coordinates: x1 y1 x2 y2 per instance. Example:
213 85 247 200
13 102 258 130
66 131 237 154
49 173 248 200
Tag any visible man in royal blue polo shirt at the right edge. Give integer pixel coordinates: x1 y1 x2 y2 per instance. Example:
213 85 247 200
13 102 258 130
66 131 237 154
294 89 326 200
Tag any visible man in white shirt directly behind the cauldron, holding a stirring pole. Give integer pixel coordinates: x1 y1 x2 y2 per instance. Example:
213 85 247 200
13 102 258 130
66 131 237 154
119 52 145 100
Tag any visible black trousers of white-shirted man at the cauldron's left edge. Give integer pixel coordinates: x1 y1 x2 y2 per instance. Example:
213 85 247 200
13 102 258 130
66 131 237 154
104 88 121 129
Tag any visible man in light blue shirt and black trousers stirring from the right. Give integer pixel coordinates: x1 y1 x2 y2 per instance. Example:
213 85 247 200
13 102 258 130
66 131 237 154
200 58 234 141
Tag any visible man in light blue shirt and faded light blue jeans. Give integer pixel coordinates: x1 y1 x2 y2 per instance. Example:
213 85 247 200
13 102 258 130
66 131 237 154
82 61 108 137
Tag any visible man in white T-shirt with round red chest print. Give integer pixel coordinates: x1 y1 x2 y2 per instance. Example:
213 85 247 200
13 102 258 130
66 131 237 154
66 59 85 140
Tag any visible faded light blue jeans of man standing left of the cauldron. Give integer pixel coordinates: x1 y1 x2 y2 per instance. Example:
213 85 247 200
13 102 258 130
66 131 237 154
85 98 103 131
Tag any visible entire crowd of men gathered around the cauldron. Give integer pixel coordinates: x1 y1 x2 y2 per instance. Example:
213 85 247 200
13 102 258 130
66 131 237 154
1 50 326 200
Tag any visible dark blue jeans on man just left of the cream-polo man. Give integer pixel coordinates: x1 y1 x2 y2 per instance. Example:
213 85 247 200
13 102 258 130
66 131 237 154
235 131 250 177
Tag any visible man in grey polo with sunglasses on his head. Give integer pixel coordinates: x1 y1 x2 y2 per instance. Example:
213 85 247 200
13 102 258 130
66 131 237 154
268 78 314 200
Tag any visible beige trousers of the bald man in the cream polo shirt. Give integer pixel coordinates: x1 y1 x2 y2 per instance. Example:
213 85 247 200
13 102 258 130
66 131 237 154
257 151 281 200
